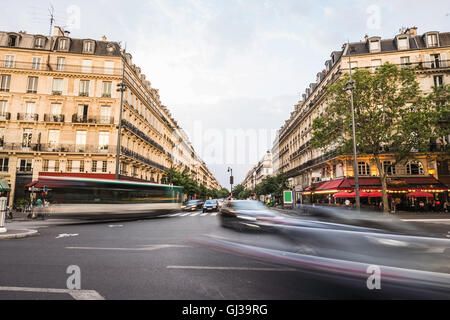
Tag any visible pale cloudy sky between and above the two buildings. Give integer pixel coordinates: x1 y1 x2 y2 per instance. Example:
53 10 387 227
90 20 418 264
0 0 450 187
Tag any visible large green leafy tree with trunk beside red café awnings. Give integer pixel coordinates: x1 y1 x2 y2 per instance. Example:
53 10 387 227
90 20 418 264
311 63 442 214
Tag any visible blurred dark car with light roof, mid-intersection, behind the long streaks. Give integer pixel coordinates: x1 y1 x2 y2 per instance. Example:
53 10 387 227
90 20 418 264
219 200 282 231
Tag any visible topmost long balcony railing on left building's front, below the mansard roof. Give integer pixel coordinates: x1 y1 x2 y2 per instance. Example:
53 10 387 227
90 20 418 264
0 60 122 75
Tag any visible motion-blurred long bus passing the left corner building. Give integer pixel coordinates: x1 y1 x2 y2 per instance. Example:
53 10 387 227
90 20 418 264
27 175 183 219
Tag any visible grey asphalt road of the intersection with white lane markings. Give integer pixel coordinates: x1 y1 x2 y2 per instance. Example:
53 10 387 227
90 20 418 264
0 211 450 300
